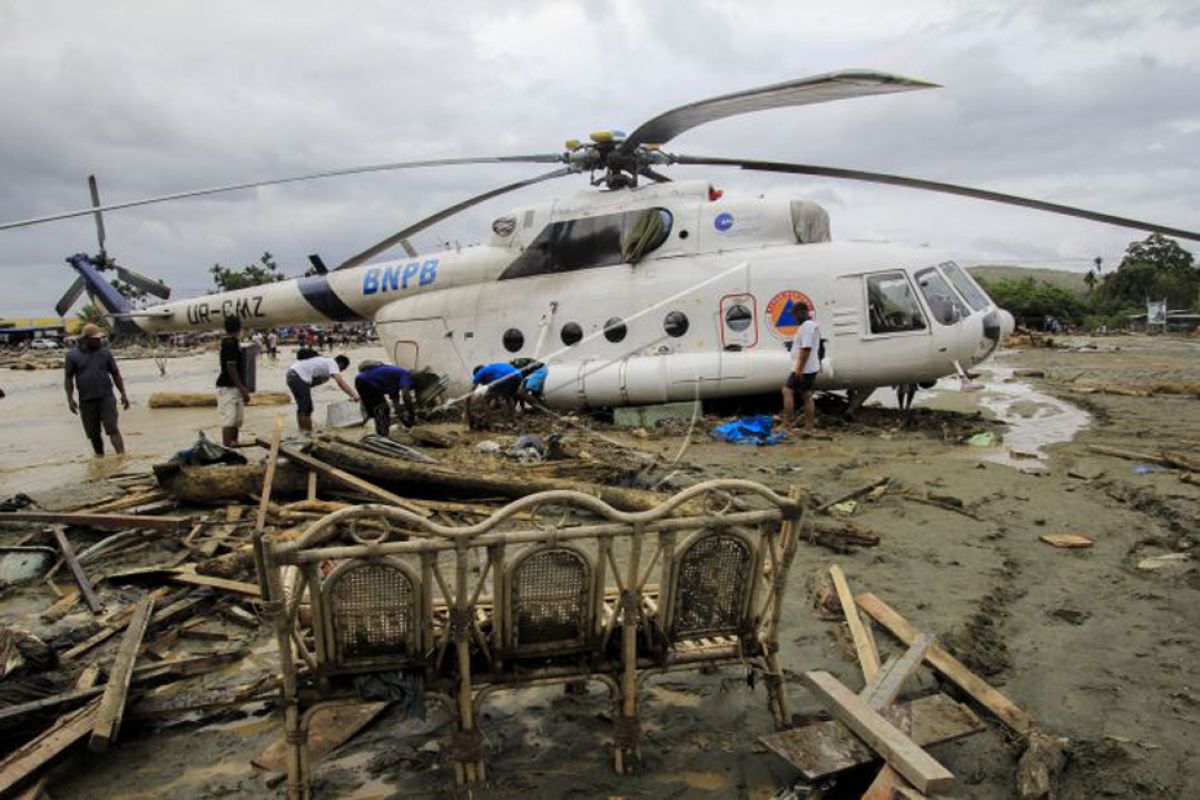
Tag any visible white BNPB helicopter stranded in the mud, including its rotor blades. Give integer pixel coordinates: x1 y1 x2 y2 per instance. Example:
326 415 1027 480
9 70 1200 408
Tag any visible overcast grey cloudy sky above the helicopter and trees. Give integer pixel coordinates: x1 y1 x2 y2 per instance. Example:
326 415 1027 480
0 0 1200 315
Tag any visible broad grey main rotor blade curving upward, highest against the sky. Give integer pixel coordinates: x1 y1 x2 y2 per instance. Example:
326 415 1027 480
618 70 940 155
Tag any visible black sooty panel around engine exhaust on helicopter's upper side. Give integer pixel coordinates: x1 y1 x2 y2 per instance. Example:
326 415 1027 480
500 209 671 281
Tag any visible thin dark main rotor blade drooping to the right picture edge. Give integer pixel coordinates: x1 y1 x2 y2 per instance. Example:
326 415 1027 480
672 156 1200 241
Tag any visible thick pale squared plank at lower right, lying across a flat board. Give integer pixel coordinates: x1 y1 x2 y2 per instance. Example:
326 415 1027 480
804 672 954 793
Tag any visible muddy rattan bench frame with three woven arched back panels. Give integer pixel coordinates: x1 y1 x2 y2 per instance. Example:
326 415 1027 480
260 480 808 798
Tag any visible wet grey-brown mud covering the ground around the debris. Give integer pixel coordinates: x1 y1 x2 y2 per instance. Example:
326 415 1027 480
0 337 1200 800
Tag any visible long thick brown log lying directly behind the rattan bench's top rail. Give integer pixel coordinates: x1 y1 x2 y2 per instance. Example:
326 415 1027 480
312 439 696 511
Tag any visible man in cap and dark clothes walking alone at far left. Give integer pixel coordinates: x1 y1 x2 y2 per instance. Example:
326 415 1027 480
64 323 130 456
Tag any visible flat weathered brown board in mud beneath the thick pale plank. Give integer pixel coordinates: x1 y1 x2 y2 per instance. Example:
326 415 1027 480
758 694 983 782
